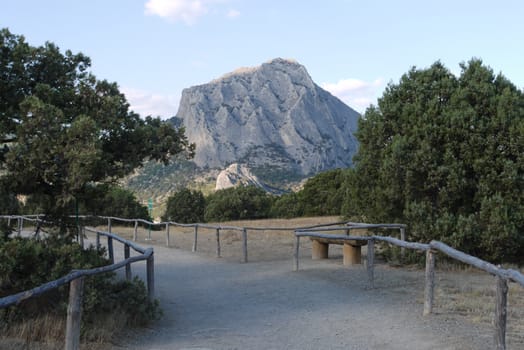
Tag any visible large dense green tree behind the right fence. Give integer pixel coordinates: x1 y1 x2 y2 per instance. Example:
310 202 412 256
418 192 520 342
344 59 524 262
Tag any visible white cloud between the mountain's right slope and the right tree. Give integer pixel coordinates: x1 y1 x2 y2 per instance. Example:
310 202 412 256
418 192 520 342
321 79 385 113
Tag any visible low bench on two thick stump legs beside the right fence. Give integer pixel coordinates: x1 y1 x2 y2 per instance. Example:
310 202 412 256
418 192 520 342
310 237 368 265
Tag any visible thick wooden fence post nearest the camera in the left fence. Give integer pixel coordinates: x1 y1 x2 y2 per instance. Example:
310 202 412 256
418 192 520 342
65 277 84 350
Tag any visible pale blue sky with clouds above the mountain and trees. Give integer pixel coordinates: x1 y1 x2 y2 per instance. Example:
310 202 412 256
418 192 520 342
0 0 524 118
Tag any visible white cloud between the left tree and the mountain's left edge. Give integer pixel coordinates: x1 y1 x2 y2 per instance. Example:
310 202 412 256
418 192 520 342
121 88 180 119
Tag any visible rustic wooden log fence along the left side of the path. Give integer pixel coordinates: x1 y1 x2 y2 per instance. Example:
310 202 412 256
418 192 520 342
0 216 155 350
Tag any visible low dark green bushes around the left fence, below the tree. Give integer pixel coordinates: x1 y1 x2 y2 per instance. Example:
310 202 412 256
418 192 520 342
0 237 160 335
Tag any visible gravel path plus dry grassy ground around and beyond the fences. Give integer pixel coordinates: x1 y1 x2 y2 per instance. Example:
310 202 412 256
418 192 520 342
2 218 524 350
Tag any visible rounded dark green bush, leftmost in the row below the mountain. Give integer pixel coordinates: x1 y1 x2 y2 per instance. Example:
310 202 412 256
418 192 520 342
162 188 206 224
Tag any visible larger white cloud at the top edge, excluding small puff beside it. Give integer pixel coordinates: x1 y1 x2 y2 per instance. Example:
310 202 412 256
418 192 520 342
145 0 208 24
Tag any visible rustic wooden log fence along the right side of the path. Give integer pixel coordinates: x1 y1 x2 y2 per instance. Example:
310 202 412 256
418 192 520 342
294 224 524 350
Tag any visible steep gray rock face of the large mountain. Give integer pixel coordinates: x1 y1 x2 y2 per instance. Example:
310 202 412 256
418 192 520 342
177 59 360 176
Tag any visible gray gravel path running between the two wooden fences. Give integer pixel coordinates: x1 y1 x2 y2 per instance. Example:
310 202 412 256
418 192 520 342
115 246 493 350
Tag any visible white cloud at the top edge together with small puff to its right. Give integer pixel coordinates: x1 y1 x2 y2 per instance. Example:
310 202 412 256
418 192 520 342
145 0 234 25
